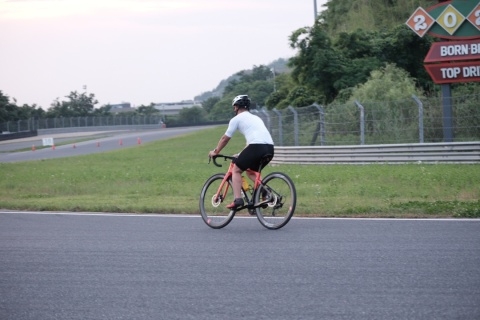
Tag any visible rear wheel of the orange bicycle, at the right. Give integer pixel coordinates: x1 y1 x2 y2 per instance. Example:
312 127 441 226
254 172 297 229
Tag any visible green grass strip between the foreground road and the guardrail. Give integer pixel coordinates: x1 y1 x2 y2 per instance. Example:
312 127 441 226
0 127 480 217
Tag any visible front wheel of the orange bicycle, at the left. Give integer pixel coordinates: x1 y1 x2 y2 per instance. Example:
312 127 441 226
199 173 235 229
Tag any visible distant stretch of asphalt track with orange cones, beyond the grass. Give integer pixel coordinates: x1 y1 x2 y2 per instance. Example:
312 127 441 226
0 127 210 162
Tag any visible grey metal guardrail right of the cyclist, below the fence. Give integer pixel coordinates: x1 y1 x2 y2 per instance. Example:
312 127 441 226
272 142 480 164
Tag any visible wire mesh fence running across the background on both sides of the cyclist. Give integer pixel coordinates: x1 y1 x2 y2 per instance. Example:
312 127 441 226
0 95 480 146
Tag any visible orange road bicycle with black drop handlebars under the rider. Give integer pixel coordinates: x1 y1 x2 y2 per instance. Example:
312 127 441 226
199 154 297 230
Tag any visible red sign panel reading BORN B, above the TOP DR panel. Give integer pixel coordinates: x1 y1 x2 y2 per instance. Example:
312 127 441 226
424 39 480 63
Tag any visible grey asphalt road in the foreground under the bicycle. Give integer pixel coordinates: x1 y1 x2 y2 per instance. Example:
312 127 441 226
0 212 480 320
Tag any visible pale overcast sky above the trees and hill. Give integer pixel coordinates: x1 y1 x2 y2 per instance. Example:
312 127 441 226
0 0 327 109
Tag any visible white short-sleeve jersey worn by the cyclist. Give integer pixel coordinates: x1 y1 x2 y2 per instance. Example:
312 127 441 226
225 111 273 145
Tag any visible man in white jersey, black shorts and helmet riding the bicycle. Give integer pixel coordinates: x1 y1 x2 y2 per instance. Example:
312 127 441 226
208 95 274 210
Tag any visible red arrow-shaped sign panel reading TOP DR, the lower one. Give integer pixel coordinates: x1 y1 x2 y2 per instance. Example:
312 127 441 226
425 60 480 84
